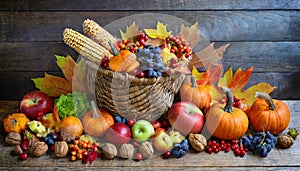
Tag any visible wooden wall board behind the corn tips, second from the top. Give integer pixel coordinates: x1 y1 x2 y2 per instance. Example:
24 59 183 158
0 10 300 42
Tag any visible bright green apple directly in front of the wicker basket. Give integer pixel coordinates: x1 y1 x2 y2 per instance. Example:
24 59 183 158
131 120 155 142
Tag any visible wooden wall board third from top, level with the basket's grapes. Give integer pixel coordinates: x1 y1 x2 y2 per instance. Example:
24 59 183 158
0 42 300 72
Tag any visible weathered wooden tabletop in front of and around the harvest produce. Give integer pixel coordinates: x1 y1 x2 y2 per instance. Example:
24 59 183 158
0 100 300 170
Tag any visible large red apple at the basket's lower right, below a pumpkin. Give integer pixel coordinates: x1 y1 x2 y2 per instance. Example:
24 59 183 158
168 101 204 135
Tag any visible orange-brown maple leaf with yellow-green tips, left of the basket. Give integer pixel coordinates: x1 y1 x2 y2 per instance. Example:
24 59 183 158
32 55 86 97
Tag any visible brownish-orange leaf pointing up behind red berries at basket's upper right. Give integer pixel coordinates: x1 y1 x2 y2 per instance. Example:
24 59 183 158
179 22 201 48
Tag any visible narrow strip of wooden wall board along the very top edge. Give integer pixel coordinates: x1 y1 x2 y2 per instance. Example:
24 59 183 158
0 0 300 11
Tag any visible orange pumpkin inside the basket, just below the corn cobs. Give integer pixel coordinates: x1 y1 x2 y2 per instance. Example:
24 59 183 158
109 50 140 73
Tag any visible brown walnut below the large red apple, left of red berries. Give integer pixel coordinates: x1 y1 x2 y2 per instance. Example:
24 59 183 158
188 133 207 152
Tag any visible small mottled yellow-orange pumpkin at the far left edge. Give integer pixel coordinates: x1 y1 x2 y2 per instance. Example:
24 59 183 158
3 113 30 133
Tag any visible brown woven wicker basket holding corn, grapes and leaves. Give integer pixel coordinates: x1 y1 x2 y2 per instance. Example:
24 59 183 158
86 61 185 121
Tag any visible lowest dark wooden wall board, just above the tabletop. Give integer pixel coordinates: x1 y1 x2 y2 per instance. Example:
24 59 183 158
0 71 300 100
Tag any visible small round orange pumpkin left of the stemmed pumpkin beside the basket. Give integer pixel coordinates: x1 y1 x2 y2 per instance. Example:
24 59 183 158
60 116 83 141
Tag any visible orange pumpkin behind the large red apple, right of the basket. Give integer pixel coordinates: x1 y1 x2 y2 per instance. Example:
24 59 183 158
180 76 211 110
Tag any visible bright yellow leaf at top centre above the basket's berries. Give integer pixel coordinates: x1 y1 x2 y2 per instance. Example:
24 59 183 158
144 21 171 40
